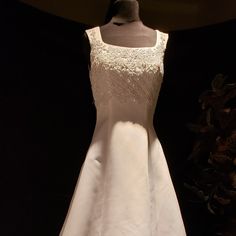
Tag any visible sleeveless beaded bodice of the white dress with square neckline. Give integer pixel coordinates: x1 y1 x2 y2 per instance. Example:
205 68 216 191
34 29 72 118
86 27 168 119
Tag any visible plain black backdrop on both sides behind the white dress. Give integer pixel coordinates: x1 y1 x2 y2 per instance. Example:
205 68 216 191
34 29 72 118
0 3 236 236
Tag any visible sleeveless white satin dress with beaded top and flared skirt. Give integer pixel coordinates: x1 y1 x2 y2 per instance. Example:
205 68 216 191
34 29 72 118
60 27 186 236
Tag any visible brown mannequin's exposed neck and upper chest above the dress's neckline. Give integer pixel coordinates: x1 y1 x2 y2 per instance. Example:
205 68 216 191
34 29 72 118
84 0 157 67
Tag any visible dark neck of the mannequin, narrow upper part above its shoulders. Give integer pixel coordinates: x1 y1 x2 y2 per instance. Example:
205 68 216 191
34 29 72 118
111 0 140 24
